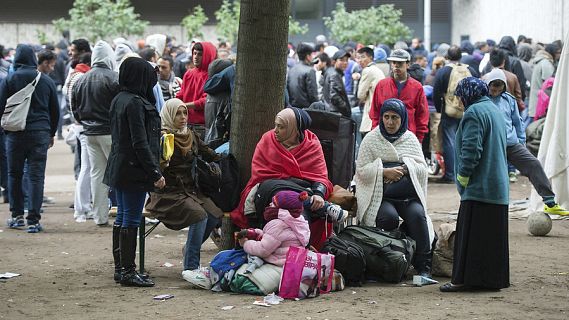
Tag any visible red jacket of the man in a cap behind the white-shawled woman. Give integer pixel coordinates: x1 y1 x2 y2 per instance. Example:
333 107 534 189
369 77 429 142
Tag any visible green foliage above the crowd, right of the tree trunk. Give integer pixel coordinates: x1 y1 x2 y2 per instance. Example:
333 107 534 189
324 2 411 45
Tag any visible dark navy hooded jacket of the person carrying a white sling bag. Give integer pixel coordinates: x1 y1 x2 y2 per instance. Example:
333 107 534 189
0 45 59 137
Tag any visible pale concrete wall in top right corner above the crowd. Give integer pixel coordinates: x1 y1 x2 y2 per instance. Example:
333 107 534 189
452 0 569 44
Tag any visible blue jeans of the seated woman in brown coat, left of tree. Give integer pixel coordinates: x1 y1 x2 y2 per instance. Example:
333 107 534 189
184 213 219 270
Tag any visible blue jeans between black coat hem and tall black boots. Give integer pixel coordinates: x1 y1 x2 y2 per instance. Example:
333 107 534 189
114 188 146 228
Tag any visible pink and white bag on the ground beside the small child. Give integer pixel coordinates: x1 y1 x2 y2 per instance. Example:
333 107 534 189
279 247 334 299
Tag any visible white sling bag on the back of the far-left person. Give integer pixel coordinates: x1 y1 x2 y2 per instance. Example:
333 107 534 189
0 72 41 131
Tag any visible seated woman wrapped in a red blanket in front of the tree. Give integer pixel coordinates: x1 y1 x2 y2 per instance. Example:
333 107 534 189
231 108 332 250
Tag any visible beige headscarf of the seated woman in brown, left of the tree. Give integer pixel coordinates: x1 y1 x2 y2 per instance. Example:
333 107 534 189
160 98 194 156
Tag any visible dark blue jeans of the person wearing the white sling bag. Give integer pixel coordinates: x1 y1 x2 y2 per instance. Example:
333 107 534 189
6 131 51 225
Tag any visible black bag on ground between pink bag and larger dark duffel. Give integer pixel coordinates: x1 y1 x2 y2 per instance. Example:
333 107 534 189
321 236 366 287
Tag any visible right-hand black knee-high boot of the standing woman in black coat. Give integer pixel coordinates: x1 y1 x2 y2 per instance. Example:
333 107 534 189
120 227 154 287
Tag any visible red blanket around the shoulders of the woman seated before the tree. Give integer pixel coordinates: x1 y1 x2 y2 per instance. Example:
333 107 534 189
231 130 333 245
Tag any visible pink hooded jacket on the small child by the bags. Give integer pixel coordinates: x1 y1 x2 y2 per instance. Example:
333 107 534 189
243 209 310 266
